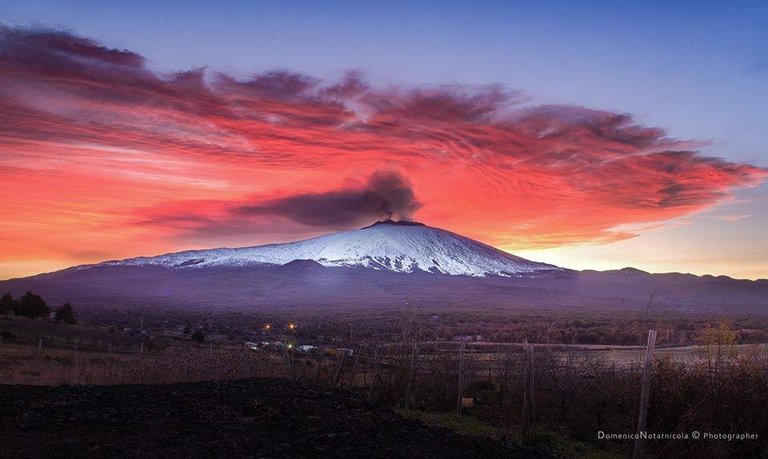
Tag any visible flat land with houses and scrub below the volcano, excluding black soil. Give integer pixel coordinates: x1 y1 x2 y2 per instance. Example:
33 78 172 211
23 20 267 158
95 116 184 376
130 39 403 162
0 308 768 457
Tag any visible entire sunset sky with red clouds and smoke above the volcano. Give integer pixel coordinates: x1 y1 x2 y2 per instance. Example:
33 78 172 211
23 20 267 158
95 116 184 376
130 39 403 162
0 0 768 279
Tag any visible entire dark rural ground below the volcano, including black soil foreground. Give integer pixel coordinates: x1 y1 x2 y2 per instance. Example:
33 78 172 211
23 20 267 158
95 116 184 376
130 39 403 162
0 305 768 458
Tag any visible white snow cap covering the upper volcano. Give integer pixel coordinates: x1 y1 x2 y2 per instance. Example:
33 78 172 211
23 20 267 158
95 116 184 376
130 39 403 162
97 220 561 277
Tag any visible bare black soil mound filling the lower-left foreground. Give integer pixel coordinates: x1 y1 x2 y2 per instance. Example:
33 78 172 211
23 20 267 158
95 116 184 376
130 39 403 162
0 379 548 458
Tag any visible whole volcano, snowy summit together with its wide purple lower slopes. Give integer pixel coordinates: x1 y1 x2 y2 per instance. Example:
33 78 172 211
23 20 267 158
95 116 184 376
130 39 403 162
0 220 768 313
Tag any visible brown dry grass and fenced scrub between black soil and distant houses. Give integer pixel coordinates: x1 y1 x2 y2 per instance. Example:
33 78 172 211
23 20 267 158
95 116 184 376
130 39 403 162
0 334 768 457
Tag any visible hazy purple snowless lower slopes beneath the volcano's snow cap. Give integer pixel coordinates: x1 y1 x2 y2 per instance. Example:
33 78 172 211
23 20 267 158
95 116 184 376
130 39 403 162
6 260 768 315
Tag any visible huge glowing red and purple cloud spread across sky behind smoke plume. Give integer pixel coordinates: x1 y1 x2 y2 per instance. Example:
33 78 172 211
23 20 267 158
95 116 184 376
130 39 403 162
0 28 768 270
